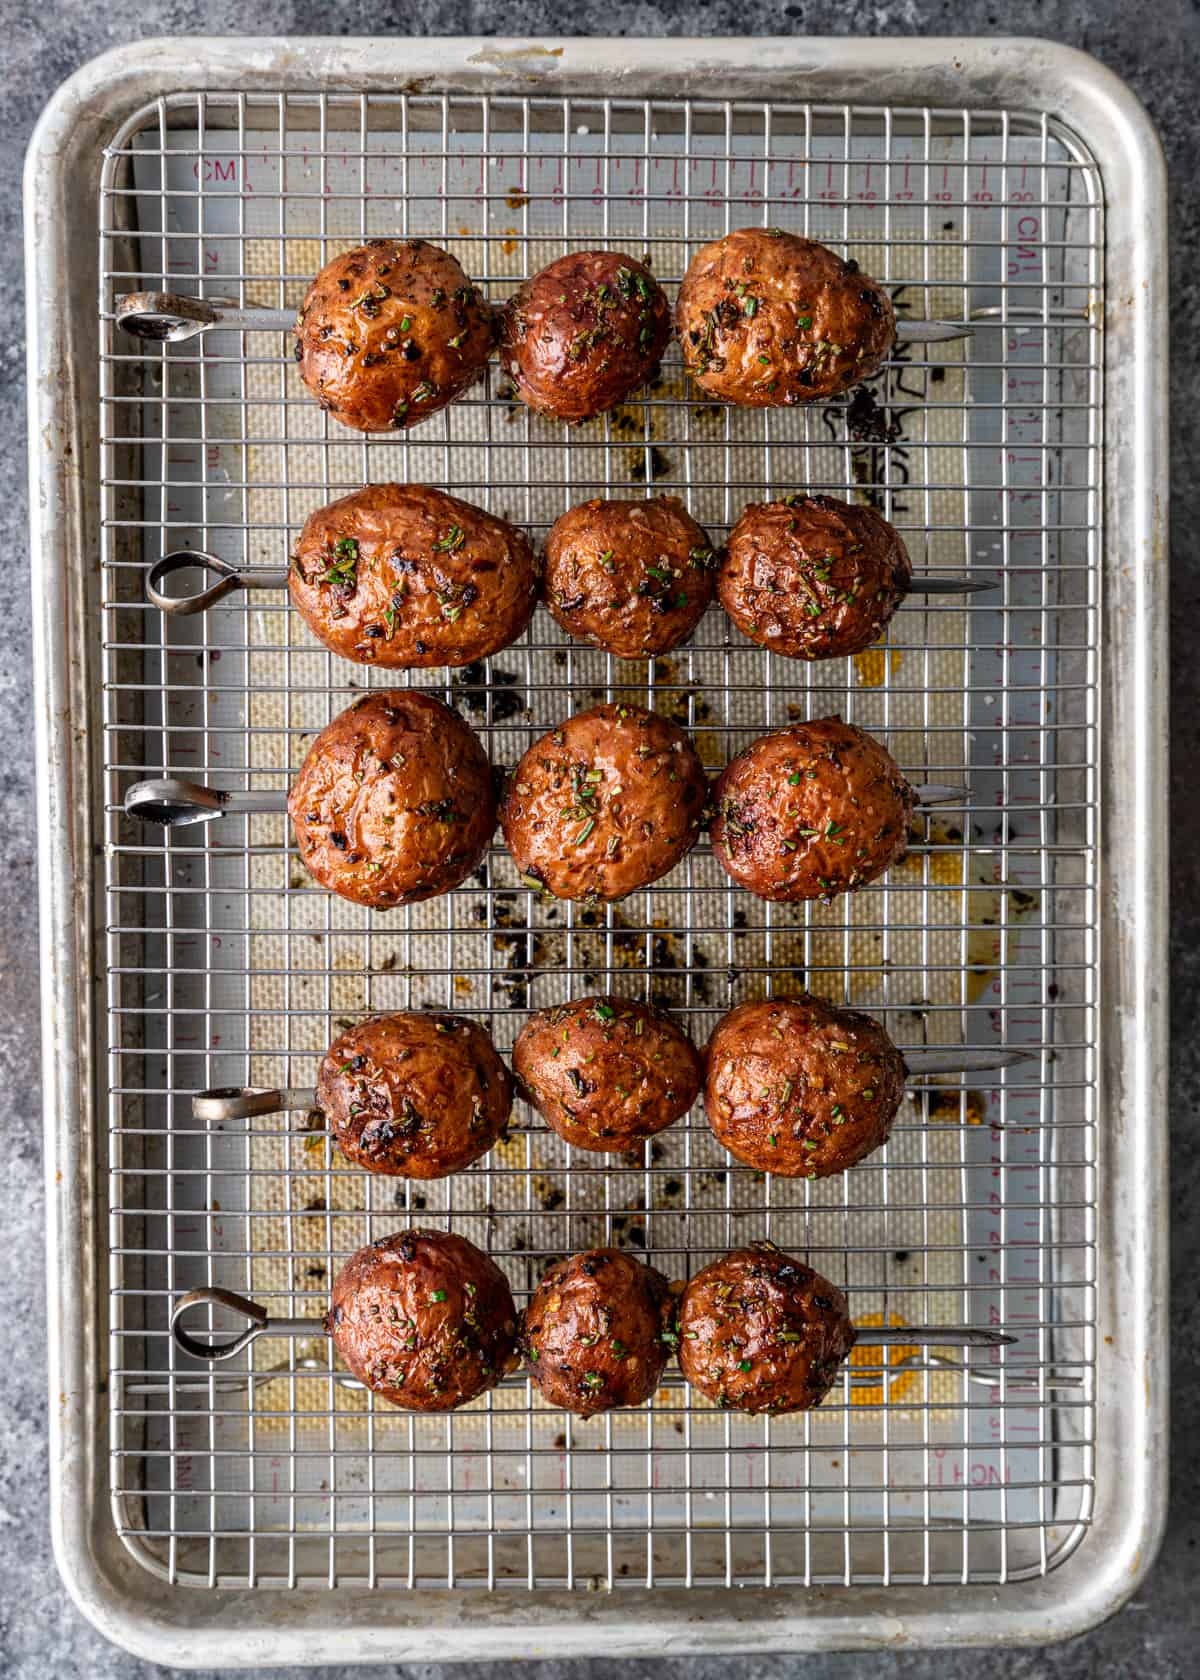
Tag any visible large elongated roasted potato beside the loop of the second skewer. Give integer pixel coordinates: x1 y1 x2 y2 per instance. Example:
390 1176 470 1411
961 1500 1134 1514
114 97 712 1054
287 484 538 670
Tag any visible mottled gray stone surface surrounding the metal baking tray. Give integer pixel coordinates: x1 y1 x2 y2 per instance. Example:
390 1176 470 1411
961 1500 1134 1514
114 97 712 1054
0 0 1200 1680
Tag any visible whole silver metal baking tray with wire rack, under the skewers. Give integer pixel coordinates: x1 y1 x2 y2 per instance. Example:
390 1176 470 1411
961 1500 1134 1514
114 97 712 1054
27 40 1166 1665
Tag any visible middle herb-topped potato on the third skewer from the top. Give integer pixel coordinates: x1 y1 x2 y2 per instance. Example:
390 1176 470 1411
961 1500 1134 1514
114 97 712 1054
501 704 708 900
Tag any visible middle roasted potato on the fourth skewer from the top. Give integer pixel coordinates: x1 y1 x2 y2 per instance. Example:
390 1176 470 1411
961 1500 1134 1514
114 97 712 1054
513 996 704 1152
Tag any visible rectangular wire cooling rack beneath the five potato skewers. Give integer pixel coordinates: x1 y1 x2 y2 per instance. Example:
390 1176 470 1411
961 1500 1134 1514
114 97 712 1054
99 92 1103 1589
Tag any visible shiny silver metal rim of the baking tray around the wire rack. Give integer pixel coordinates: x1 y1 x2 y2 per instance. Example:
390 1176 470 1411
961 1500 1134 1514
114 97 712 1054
25 39 1168 1668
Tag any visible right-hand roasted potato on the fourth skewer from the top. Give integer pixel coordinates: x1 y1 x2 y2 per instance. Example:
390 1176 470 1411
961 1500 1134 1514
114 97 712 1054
704 996 904 1178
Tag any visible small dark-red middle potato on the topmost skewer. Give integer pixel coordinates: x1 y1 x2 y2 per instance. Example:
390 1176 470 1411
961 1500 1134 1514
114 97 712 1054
501 250 671 423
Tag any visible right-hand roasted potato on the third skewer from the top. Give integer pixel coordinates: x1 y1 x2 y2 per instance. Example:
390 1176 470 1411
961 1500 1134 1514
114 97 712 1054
711 717 916 904
